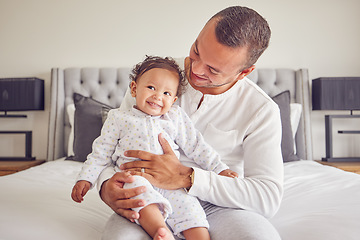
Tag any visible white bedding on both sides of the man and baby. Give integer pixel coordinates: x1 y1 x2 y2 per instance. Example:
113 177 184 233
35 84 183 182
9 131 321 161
0 159 360 240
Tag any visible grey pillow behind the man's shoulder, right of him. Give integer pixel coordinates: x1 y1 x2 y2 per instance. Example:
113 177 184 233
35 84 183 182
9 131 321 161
272 91 300 162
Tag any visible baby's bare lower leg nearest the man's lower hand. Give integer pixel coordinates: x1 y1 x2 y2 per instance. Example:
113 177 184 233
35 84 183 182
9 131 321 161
139 204 174 240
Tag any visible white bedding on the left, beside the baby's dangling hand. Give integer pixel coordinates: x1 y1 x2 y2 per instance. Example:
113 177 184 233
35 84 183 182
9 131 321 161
0 160 112 240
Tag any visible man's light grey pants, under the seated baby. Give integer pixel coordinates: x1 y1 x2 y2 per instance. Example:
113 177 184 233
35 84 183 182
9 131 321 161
102 203 281 240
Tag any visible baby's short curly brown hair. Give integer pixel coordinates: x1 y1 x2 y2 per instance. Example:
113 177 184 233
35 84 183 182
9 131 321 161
130 55 187 96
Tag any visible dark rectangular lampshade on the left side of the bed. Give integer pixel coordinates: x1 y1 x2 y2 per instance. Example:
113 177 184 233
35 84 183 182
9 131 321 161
0 78 44 117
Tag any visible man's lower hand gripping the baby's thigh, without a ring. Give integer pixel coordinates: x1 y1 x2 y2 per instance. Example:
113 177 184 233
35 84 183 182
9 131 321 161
100 172 146 222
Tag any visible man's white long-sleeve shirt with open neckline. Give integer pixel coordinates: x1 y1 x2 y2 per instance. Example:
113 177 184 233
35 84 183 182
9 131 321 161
98 78 283 217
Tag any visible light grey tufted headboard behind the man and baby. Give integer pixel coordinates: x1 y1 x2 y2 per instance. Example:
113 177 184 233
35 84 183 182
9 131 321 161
47 68 312 161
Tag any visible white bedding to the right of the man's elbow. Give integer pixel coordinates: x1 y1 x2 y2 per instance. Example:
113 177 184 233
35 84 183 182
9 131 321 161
270 161 360 240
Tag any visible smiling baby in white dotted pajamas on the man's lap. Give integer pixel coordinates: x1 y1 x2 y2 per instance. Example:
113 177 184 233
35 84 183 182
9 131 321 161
71 56 238 240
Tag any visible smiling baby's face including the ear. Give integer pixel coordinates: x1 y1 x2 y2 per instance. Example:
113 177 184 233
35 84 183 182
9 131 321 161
130 68 179 116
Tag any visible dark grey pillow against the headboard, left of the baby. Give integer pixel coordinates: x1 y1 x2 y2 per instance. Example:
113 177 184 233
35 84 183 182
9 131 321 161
67 93 112 162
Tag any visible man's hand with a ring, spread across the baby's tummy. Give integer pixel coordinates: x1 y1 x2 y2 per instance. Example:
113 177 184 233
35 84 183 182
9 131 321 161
120 134 192 189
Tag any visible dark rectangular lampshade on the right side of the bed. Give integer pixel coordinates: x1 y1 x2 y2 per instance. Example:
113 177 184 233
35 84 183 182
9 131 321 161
312 77 360 110
